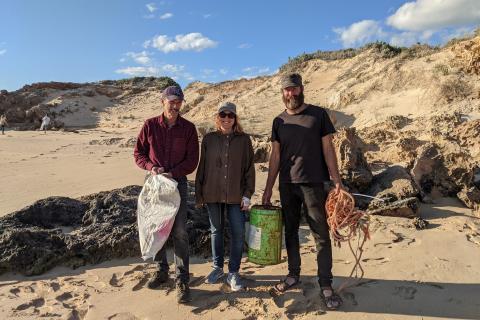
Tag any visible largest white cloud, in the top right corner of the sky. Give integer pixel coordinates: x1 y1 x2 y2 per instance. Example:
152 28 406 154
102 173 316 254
387 0 480 31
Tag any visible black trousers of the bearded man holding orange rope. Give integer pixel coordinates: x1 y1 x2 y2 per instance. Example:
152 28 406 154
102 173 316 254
279 183 333 287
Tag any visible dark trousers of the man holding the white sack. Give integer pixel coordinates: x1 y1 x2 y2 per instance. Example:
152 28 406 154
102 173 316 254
154 178 190 283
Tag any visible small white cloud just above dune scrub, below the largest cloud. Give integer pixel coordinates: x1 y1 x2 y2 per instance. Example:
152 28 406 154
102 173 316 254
333 20 387 47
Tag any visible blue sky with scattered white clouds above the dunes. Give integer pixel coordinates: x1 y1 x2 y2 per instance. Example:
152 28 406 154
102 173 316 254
0 0 480 91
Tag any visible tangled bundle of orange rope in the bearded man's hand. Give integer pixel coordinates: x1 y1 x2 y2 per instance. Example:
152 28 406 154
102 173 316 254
325 189 370 292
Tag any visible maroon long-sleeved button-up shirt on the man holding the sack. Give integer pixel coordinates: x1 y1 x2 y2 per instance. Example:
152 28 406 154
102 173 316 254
134 114 198 178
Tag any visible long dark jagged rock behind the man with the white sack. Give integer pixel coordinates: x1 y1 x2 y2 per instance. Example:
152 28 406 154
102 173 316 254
0 182 214 275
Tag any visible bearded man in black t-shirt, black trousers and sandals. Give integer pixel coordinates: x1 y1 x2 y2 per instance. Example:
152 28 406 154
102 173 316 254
262 73 343 309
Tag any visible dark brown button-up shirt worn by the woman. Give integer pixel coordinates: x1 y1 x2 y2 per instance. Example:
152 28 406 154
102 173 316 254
195 132 255 204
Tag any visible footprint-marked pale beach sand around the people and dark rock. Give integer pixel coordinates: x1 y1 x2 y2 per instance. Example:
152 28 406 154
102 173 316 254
0 129 480 319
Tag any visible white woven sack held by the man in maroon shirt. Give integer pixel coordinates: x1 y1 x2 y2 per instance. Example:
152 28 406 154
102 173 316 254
137 175 180 260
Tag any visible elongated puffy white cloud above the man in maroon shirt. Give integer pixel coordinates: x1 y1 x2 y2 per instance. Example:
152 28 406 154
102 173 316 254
144 32 218 53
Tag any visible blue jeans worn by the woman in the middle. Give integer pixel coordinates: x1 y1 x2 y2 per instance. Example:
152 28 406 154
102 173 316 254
207 203 245 272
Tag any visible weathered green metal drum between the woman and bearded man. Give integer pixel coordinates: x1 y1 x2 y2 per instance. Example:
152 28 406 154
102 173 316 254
248 206 282 265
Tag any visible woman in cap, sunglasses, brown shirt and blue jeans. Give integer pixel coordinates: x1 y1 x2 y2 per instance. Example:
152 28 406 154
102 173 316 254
195 102 255 291
